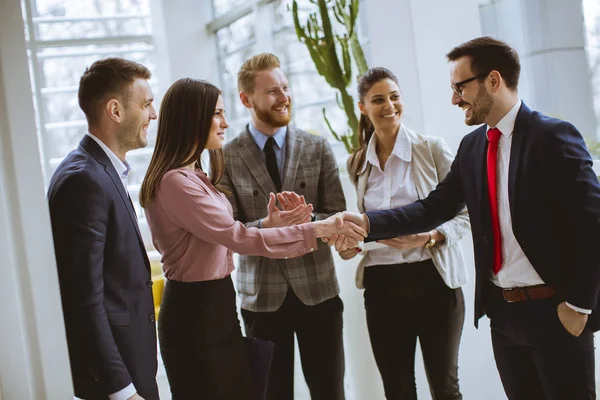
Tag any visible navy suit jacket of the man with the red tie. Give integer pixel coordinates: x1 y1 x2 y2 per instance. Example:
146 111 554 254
367 103 600 326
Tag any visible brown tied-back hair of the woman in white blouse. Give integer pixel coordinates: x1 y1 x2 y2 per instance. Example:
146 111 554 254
348 67 399 183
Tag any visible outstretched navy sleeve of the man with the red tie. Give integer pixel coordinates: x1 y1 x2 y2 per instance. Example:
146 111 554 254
365 139 468 242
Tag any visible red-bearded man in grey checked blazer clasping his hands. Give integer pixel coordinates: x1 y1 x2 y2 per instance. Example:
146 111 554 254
220 53 346 400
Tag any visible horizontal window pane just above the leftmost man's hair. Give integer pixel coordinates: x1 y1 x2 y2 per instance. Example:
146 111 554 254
38 43 156 87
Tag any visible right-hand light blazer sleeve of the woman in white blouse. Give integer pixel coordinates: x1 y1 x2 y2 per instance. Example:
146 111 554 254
431 137 471 249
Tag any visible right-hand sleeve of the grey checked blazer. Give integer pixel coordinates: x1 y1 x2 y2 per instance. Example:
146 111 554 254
314 138 346 220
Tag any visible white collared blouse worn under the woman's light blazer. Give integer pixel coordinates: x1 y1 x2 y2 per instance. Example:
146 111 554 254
363 125 431 267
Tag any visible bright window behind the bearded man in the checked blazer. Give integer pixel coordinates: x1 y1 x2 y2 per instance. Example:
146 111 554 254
208 0 366 164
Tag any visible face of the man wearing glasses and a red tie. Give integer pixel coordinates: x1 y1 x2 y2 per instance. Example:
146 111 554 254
450 57 494 125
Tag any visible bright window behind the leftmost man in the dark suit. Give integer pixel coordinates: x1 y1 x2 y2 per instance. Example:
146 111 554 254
22 0 159 255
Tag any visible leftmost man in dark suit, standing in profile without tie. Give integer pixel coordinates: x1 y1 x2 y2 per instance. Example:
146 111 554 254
48 58 158 400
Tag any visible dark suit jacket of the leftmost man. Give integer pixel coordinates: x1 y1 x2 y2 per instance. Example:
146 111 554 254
48 135 158 400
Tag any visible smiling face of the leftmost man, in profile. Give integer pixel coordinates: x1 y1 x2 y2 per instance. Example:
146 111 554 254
116 79 157 151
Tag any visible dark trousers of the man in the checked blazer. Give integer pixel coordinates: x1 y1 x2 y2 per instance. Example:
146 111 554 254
242 288 345 400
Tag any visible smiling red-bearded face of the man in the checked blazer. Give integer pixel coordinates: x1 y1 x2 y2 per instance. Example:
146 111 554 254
246 68 292 133
